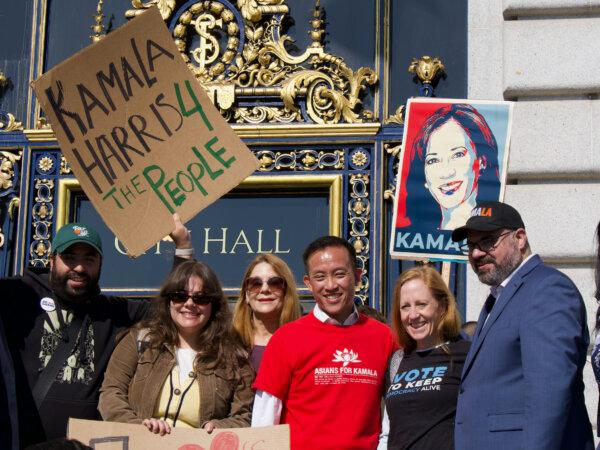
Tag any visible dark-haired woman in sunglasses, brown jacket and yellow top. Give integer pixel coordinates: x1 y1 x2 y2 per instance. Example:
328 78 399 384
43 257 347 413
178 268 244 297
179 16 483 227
98 261 253 435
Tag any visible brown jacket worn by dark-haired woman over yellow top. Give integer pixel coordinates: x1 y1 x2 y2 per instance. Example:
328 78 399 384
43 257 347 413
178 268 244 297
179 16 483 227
98 330 254 428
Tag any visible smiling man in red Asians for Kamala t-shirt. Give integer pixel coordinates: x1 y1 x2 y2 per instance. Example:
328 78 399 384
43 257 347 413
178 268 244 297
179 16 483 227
252 236 395 449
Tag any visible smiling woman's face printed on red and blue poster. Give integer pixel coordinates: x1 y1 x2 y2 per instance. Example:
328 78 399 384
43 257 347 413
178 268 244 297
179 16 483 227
425 119 480 209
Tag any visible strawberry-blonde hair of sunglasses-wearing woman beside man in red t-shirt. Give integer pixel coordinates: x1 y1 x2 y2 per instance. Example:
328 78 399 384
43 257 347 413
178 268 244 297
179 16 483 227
233 253 300 348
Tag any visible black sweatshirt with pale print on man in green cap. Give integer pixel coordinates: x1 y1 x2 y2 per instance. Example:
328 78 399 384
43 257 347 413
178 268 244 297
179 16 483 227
0 272 150 447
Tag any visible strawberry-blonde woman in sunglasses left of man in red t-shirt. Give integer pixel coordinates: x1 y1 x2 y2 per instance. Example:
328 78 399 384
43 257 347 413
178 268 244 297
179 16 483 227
233 253 300 371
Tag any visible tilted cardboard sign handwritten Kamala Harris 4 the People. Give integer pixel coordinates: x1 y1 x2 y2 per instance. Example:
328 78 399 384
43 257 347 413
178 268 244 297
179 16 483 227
33 8 258 256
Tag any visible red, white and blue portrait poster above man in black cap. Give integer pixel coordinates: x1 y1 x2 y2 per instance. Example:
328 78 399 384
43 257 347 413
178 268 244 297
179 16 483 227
390 98 513 261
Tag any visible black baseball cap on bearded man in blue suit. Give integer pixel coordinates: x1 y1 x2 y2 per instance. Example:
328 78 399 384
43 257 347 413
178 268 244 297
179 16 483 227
452 202 525 242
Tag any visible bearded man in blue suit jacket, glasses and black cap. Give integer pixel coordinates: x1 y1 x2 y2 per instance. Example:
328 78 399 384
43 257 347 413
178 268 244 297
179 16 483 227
452 202 593 450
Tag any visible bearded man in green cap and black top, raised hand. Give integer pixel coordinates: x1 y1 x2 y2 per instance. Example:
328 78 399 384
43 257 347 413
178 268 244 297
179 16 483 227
0 216 192 448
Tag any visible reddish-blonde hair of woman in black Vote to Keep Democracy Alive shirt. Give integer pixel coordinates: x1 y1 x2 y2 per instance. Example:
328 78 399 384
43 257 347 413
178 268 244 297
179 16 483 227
392 266 460 353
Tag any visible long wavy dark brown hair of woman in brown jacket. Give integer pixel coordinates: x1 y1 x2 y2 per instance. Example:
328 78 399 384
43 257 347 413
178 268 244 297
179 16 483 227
138 261 247 370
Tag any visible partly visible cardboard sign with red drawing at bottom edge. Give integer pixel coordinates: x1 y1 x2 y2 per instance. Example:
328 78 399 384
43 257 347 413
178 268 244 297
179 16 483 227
68 419 290 450
